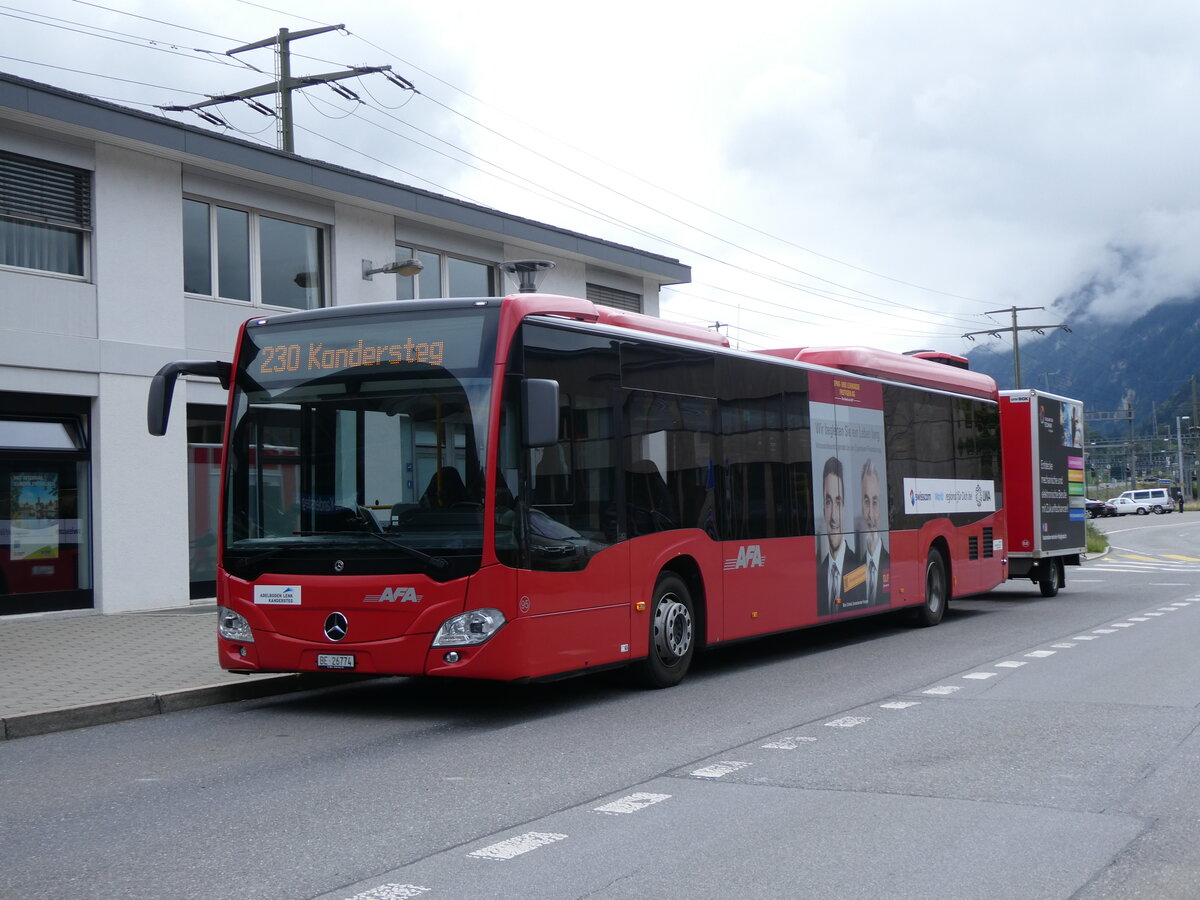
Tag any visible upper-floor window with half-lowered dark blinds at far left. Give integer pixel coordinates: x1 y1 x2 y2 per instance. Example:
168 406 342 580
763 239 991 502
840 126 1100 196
0 152 91 277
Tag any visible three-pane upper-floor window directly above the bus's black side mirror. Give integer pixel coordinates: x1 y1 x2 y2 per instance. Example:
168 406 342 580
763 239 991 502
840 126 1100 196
184 197 325 310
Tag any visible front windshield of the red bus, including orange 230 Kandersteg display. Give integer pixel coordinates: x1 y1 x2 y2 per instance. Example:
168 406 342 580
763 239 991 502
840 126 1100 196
224 307 496 577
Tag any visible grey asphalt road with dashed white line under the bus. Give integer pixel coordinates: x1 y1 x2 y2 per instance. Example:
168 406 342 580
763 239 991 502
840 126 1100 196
0 514 1200 900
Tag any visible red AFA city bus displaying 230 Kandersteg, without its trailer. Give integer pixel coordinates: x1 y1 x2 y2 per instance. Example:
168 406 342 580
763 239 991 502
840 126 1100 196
148 293 1006 686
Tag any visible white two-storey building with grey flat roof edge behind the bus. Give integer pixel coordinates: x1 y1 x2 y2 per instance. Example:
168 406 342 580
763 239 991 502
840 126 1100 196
0 74 690 614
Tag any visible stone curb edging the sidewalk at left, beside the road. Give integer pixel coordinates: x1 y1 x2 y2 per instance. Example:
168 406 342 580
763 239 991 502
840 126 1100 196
0 674 349 740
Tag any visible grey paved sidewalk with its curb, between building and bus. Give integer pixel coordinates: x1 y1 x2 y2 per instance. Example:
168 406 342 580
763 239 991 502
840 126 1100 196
0 605 326 739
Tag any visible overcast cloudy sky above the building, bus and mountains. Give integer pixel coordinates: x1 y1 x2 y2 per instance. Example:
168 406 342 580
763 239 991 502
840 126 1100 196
0 0 1200 352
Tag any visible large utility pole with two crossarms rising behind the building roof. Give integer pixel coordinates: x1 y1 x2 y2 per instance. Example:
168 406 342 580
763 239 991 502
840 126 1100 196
158 25 415 154
